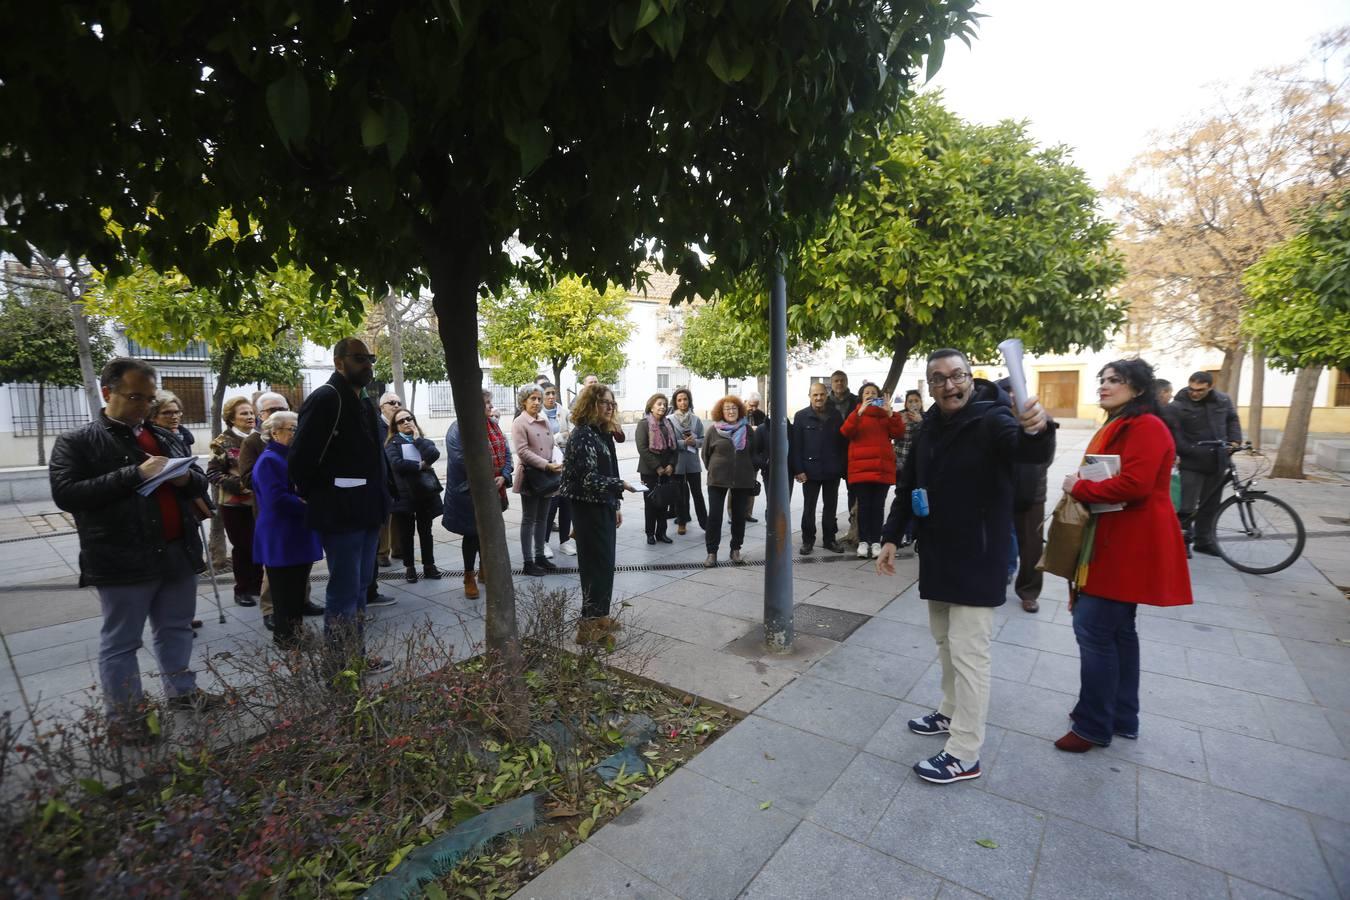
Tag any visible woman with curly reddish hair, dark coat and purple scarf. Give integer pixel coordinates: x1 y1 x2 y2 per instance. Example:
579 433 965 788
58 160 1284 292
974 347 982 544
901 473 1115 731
703 397 760 568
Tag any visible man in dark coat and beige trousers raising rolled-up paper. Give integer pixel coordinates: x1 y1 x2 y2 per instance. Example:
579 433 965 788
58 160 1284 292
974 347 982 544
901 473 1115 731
876 349 1054 784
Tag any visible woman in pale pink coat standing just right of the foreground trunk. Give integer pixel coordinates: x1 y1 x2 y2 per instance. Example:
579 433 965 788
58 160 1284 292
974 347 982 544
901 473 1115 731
510 385 563 576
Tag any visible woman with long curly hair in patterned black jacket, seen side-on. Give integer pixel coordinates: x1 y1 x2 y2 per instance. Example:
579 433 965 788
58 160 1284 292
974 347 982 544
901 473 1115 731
562 385 633 644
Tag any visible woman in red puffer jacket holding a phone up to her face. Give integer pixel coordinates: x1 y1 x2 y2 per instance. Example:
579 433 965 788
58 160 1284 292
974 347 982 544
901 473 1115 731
840 382 905 560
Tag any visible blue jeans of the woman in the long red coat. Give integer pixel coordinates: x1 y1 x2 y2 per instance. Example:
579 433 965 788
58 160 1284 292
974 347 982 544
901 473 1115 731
1071 594 1139 746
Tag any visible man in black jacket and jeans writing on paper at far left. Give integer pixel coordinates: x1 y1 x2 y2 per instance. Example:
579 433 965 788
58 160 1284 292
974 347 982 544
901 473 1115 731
49 358 220 742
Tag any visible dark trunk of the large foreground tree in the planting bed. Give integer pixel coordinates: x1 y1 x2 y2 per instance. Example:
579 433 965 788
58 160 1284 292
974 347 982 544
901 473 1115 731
424 235 529 735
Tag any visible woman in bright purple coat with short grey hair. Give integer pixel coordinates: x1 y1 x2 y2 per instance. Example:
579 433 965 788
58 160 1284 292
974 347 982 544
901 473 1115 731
252 412 324 650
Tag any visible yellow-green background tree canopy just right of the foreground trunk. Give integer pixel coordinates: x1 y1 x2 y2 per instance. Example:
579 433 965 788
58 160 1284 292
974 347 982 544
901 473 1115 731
483 275 633 385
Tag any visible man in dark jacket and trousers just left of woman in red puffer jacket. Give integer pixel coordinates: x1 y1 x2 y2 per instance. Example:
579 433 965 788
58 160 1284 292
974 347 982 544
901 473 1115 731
790 385 848 556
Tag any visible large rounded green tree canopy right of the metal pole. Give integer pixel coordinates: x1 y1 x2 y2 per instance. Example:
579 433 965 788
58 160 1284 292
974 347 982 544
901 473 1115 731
733 94 1123 391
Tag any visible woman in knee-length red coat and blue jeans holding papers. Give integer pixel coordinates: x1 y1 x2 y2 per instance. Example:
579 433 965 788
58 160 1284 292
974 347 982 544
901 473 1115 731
1054 359 1191 753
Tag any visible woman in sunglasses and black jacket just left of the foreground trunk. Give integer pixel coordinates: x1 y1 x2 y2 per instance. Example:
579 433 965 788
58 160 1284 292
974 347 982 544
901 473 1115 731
385 409 443 584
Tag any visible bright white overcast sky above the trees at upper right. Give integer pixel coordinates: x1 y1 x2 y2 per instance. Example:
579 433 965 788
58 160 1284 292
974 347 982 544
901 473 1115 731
933 0 1350 188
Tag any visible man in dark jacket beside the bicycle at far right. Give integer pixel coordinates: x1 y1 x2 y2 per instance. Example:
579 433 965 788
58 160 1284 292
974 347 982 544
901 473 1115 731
1168 371 1242 555
